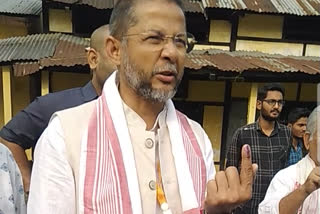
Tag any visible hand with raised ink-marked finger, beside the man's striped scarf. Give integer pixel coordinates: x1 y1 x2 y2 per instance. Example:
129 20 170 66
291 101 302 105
205 144 258 214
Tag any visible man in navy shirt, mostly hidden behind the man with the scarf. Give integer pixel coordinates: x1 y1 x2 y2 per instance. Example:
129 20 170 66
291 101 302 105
0 25 116 194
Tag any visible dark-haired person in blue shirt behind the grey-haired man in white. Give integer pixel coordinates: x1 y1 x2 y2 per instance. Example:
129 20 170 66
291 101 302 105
288 108 310 166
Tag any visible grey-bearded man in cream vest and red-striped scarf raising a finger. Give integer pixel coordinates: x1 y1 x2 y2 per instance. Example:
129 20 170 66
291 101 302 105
28 0 257 214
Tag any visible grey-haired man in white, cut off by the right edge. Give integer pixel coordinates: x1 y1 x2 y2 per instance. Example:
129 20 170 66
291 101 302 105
259 106 320 214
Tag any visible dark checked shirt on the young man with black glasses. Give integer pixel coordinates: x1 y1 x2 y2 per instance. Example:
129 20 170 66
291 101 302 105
227 120 291 214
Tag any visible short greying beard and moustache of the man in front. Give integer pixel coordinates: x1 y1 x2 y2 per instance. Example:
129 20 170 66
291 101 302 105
122 48 182 103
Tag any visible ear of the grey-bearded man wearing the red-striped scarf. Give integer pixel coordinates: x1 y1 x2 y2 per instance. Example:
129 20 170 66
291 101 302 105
105 36 121 66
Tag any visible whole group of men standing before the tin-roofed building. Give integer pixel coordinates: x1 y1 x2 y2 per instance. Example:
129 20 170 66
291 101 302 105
0 0 320 214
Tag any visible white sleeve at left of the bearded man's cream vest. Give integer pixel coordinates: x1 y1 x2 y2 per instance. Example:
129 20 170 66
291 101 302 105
27 117 75 214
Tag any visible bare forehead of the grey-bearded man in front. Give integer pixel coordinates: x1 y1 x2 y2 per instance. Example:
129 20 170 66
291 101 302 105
128 0 186 34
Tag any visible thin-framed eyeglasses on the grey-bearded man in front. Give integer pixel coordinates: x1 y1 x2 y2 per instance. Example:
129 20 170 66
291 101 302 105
123 31 196 54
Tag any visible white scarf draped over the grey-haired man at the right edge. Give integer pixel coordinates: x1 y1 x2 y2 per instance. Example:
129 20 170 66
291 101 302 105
294 155 320 214
